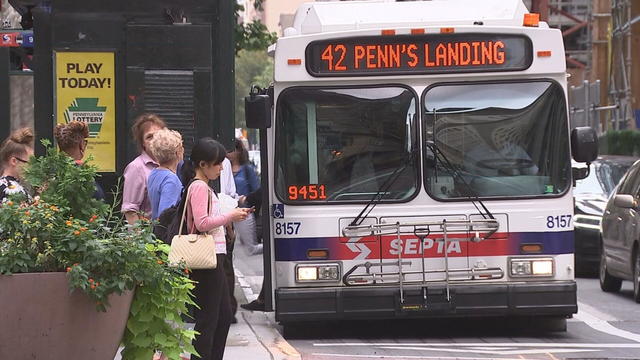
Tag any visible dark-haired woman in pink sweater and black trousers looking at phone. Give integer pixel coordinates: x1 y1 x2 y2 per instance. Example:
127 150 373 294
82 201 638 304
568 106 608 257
179 138 251 360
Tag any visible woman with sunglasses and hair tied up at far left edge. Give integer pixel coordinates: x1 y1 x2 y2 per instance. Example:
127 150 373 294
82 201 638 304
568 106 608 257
0 128 33 203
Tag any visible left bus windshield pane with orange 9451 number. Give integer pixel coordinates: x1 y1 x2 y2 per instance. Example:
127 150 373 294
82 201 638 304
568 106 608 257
275 86 419 202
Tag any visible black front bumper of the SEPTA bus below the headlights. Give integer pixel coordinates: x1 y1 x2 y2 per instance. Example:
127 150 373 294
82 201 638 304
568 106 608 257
275 281 578 322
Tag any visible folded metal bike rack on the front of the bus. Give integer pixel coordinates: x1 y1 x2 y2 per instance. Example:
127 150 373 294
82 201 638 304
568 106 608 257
342 219 504 303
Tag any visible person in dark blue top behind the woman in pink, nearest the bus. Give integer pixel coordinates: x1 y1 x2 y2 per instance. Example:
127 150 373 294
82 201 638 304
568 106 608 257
227 139 262 254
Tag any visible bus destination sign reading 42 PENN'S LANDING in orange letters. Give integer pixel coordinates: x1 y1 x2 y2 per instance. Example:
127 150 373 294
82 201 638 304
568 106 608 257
306 33 533 77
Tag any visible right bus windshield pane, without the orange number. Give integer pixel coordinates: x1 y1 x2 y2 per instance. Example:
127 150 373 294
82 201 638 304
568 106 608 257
424 81 571 200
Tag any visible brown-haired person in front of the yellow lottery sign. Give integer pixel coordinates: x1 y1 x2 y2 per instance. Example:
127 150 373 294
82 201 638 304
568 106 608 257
53 120 104 200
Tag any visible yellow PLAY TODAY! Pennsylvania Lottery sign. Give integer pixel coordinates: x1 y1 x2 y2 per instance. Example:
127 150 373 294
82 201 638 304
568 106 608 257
55 52 116 172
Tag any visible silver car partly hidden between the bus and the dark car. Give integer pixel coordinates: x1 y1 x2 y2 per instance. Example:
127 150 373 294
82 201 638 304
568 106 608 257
573 155 638 275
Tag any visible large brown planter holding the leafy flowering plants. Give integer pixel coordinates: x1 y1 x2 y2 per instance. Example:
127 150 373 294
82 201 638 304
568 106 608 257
0 273 133 360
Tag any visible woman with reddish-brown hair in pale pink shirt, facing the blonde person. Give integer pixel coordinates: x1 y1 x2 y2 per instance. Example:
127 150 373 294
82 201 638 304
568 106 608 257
122 114 167 224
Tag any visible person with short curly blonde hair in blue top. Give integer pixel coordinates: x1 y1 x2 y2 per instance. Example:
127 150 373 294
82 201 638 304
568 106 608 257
147 129 184 219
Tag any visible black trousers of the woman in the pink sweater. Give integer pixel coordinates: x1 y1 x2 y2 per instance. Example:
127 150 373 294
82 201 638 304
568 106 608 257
191 254 232 360
